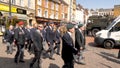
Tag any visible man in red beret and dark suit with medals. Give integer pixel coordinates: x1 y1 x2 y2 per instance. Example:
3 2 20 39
15 21 25 63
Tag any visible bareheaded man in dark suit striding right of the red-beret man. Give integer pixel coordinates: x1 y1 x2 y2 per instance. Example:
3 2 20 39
30 25 43 68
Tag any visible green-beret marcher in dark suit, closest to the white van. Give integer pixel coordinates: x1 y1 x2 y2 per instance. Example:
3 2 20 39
75 24 85 64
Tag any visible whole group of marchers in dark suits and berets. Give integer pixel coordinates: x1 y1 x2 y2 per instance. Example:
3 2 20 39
4 21 120 68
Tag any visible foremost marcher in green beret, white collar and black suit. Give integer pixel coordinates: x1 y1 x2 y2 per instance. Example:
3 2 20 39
62 24 77 68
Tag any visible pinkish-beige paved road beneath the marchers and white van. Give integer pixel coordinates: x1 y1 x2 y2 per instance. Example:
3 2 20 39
0 37 120 68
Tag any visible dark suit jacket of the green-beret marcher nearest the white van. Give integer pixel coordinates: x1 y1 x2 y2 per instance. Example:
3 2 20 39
75 29 85 50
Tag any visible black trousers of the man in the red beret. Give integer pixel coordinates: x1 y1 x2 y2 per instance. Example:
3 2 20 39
15 45 24 61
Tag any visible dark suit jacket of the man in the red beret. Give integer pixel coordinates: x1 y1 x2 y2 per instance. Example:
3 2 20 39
15 28 25 45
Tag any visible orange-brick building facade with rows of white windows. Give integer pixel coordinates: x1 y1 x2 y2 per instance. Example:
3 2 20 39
35 0 68 23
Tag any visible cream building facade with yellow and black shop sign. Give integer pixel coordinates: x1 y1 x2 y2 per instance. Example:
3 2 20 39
0 0 35 24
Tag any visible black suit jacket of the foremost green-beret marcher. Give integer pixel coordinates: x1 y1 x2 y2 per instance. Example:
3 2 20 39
62 33 77 61
